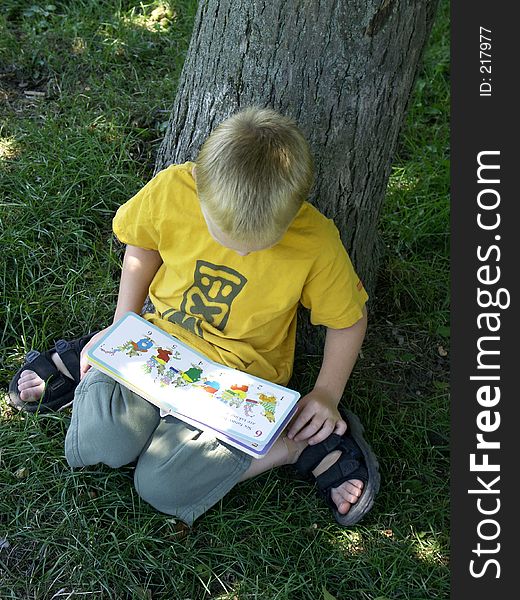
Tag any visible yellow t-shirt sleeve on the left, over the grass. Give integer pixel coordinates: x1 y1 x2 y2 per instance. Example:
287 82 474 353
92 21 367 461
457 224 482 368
112 174 160 250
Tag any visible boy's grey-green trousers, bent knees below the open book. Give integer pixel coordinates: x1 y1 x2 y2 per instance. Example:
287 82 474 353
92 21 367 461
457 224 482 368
65 369 252 525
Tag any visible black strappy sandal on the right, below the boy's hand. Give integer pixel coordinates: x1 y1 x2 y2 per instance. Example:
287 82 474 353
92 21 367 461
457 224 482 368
294 411 381 526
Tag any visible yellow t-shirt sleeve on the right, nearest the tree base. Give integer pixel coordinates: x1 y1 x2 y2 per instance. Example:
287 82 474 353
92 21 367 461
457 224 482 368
301 220 368 329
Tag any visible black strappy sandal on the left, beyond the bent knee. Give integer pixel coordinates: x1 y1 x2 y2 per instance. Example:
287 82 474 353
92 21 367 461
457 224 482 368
9 332 97 413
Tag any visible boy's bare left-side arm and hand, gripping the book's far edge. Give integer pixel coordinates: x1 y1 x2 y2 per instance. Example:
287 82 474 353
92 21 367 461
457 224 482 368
80 245 162 377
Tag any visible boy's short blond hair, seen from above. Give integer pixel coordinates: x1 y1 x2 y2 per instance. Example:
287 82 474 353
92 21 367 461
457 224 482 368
196 107 314 244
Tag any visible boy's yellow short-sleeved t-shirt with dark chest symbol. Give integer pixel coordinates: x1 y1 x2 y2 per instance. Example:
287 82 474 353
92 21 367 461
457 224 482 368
113 162 368 385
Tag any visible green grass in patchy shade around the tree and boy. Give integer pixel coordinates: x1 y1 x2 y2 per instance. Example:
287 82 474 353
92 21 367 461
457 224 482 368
0 0 449 600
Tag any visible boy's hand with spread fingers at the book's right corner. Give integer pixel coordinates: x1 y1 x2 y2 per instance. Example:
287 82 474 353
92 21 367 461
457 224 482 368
287 388 347 445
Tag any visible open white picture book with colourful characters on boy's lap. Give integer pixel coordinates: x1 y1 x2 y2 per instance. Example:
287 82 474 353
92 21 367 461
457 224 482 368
87 312 300 458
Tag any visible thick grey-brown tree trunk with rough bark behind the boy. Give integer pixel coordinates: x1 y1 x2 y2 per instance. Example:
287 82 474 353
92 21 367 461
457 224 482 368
156 0 438 351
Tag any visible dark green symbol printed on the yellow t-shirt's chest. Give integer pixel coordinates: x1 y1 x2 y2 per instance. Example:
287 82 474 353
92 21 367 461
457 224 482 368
163 260 247 337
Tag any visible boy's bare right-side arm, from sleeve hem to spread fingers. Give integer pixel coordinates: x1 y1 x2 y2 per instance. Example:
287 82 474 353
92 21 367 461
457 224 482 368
287 307 367 445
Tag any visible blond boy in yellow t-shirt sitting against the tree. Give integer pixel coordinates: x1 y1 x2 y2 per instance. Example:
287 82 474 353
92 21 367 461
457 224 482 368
11 108 379 525
